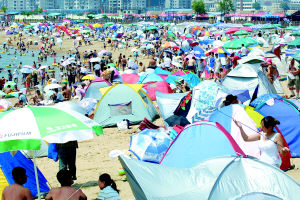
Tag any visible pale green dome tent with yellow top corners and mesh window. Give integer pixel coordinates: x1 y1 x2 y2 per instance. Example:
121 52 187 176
94 84 158 127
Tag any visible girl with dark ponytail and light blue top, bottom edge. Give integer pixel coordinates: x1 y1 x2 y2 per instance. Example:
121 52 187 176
96 174 120 200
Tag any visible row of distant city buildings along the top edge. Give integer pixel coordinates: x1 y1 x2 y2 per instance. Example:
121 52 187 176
0 0 300 13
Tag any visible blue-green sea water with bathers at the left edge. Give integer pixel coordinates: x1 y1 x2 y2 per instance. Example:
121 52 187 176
0 47 61 88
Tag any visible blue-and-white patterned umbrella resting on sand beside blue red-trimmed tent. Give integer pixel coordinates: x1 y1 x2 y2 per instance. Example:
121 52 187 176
129 129 172 163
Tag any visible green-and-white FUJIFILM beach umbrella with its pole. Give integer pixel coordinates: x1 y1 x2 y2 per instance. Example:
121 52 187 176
0 106 98 199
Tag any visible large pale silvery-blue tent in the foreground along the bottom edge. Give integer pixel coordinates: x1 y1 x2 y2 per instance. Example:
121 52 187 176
119 155 300 200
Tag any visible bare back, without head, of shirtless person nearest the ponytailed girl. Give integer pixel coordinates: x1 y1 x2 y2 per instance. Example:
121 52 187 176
45 186 87 200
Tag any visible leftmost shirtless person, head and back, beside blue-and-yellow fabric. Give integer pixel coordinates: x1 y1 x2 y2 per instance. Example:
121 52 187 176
2 167 33 200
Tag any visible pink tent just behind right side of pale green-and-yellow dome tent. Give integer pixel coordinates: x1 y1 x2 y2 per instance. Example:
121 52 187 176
143 81 173 101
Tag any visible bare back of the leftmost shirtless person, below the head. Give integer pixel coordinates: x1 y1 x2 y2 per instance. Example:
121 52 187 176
2 184 33 200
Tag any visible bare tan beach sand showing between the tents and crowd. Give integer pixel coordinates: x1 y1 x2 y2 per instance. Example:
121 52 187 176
0 33 300 200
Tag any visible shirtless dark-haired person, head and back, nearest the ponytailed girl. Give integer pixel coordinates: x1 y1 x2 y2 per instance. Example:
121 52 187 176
45 170 87 200
